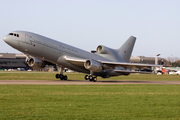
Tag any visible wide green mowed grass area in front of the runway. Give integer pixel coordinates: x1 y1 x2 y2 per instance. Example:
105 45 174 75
0 85 180 120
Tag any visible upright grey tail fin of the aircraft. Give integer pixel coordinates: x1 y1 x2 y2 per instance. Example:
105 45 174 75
117 36 136 62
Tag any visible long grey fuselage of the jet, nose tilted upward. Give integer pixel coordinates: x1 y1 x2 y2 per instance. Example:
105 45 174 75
4 31 120 77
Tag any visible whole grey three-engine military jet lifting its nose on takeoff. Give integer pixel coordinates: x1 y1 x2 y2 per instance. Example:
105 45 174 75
3 31 161 82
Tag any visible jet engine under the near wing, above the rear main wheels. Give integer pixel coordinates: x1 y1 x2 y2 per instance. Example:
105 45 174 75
84 60 102 72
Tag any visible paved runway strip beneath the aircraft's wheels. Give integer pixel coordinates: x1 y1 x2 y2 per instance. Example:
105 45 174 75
0 80 180 85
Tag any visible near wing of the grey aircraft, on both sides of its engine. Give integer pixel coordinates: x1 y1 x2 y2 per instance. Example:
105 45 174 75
64 56 162 69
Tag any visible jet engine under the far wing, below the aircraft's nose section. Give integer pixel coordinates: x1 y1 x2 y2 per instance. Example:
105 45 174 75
27 57 45 69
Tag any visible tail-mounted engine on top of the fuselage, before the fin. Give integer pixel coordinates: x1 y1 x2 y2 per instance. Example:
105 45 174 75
96 45 113 54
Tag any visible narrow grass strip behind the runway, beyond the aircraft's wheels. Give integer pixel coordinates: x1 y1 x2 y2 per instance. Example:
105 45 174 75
0 72 180 81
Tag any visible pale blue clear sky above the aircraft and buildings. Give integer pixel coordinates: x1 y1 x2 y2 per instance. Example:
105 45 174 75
0 0 180 58
